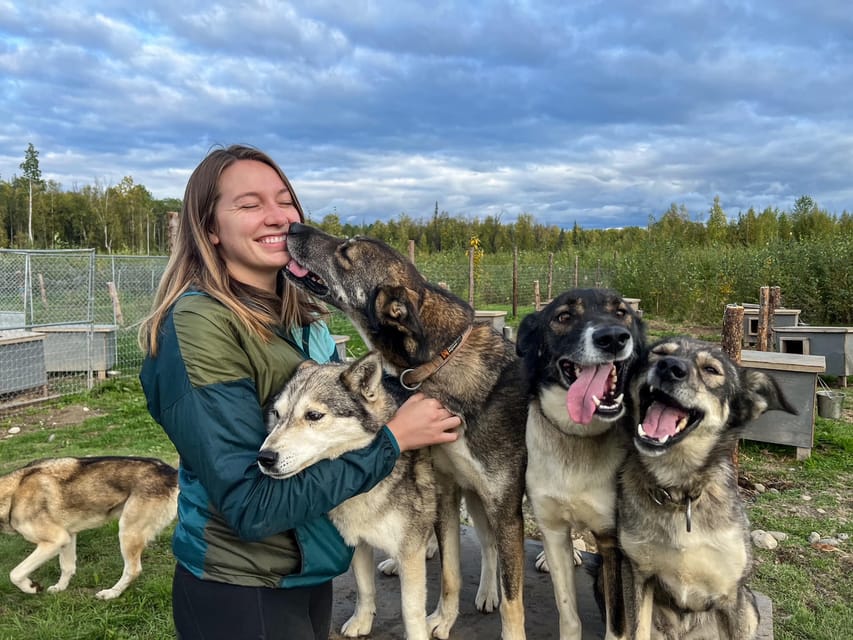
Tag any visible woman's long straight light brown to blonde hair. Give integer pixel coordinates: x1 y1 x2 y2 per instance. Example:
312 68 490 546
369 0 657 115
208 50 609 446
138 145 327 355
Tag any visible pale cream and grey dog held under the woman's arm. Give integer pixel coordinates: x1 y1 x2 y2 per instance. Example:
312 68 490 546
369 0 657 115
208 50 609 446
258 352 436 640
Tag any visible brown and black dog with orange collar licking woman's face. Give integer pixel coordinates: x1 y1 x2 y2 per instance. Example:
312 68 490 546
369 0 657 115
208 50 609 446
287 224 528 640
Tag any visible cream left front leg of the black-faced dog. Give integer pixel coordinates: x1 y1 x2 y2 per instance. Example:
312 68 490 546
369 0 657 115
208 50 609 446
540 522 581 640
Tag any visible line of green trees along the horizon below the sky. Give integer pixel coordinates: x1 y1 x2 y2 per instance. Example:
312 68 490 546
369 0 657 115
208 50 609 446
0 144 853 255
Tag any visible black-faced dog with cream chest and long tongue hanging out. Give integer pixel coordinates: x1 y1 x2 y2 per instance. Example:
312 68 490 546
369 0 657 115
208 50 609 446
517 289 645 640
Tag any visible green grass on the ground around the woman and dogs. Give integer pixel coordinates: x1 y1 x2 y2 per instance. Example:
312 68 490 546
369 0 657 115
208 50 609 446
0 328 853 640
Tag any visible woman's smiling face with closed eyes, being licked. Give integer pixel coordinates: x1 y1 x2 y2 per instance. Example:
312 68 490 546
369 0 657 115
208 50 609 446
208 160 299 292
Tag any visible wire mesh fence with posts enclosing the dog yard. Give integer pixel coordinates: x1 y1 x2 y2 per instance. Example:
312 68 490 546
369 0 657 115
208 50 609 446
0 249 609 411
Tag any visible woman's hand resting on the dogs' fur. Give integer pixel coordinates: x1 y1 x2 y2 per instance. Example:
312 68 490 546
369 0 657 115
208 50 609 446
388 393 462 451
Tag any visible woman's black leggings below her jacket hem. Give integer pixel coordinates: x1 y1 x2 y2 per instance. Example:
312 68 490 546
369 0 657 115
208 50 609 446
172 565 332 640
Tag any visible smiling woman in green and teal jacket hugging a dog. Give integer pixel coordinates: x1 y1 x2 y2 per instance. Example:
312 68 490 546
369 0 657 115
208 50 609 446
140 146 460 640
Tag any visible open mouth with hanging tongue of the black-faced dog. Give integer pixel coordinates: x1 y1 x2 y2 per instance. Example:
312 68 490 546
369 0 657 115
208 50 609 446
558 358 624 425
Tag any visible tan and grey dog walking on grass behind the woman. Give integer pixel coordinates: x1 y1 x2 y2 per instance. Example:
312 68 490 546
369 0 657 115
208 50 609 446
0 456 178 600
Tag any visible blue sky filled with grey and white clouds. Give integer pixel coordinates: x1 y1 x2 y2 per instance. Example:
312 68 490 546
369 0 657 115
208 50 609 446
0 0 853 229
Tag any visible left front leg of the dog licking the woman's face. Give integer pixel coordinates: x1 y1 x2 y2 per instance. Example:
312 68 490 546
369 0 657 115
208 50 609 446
427 475 462 640
